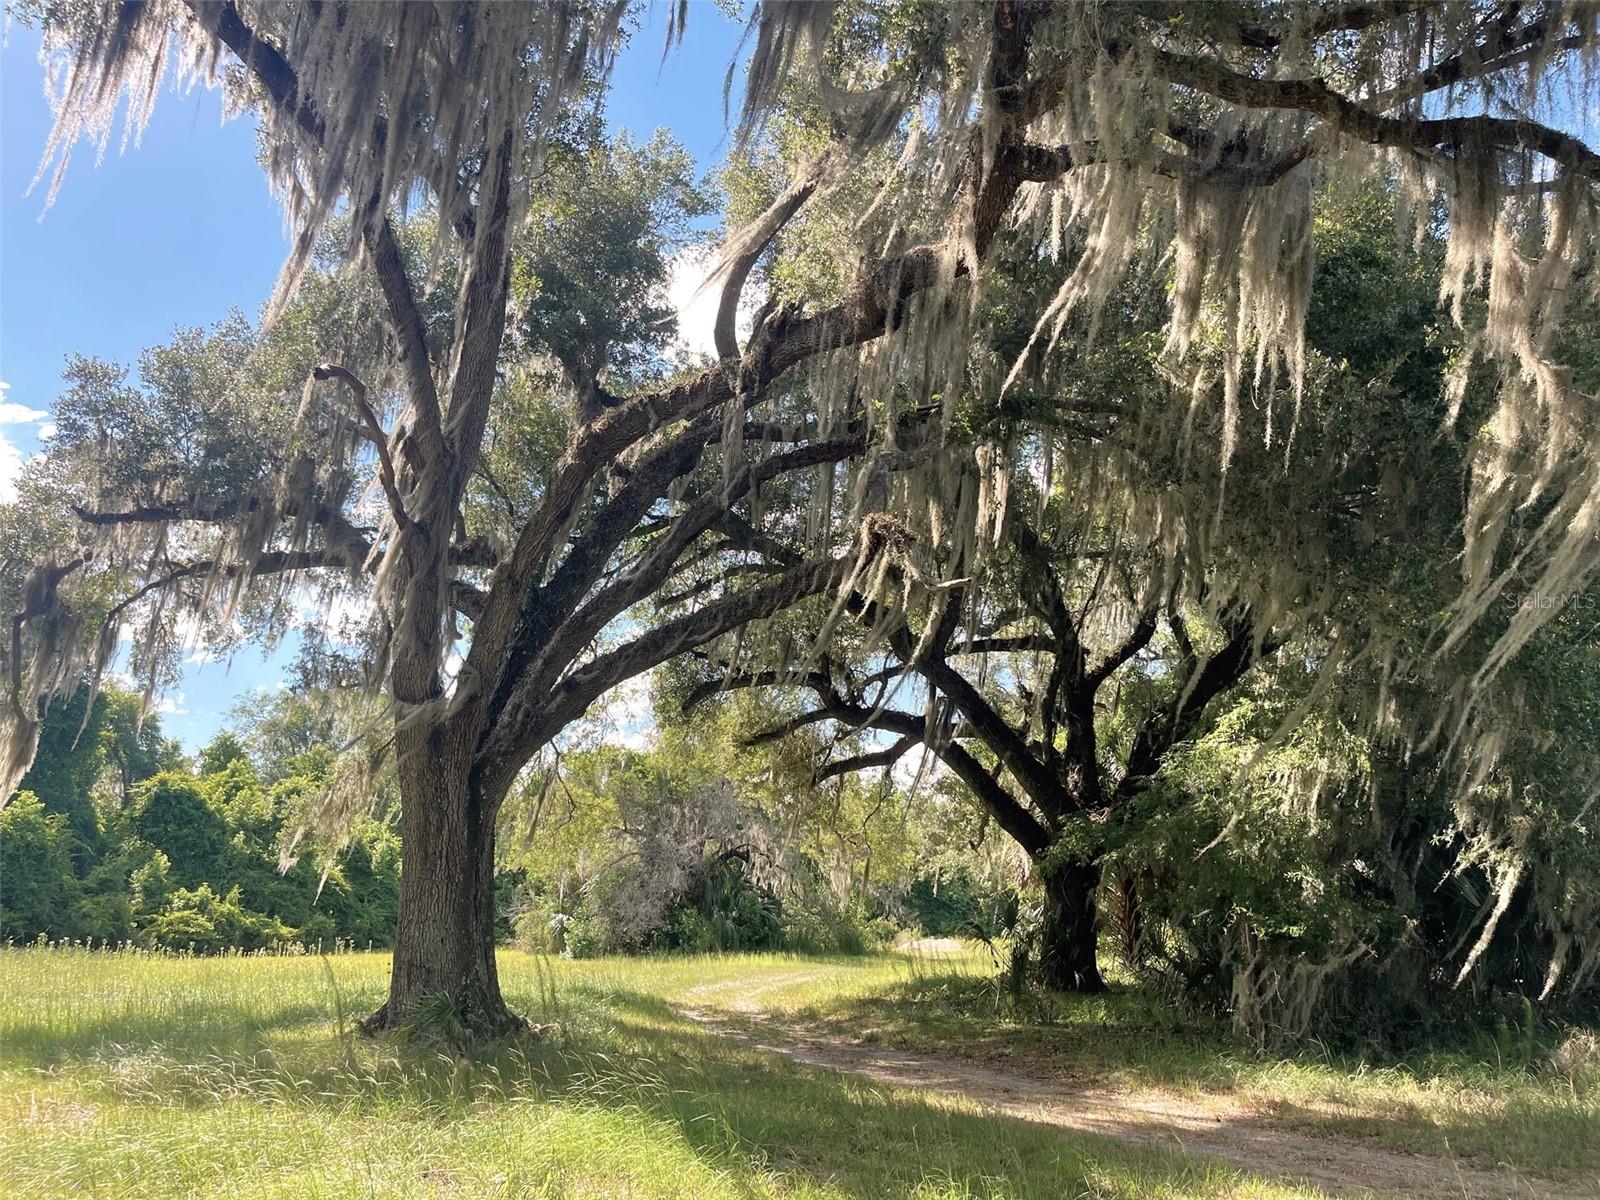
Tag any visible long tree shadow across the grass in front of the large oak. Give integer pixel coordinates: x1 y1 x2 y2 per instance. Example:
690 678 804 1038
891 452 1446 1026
6 986 1324 1200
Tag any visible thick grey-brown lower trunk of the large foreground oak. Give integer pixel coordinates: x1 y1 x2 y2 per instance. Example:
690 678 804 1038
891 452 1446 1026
362 736 526 1038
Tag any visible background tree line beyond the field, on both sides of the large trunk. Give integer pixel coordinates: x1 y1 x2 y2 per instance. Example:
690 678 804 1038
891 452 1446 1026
0 683 1016 957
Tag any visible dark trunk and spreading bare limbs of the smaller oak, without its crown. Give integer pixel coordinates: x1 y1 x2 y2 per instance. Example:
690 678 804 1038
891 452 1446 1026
696 523 1269 992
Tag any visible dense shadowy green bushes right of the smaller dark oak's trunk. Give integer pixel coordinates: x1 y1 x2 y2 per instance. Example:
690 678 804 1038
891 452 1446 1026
1101 624 1600 1045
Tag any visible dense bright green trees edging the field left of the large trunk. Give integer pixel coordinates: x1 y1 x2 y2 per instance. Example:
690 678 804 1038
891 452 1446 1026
0 685 400 952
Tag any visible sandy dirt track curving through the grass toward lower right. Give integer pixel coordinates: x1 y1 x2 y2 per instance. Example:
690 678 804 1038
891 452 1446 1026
678 971 1600 1200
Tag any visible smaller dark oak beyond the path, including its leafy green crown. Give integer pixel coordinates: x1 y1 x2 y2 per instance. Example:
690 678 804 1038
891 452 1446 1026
680 190 1466 990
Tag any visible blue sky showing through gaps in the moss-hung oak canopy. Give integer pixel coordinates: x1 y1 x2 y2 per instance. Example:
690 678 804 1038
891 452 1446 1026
0 0 741 749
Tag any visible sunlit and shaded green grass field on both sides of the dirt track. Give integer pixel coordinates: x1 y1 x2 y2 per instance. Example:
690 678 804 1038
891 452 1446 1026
0 949 1600 1198
